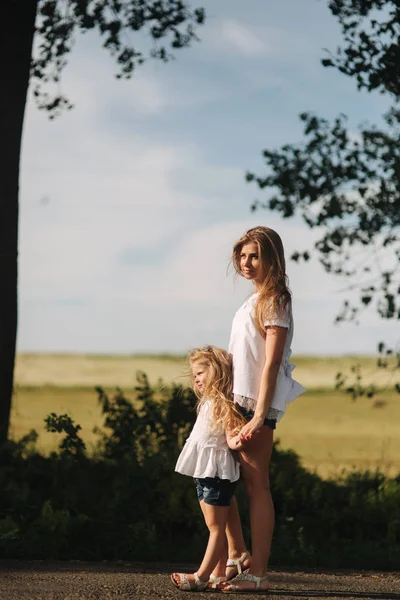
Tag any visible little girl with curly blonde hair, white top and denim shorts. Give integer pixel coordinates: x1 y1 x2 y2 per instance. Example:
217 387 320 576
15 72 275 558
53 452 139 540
171 346 246 592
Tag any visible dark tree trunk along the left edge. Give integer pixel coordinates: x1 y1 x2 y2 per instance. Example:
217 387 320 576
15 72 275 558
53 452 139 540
0 0 37 445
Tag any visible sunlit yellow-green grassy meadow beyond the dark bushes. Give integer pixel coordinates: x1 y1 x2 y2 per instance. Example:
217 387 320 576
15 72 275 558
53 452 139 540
11 354 400 476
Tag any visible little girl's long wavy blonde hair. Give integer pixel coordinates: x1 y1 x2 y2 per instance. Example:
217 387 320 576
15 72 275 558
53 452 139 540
188 346 246 433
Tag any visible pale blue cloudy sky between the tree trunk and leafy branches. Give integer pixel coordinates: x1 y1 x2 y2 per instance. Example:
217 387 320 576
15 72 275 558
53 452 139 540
18 0 394 354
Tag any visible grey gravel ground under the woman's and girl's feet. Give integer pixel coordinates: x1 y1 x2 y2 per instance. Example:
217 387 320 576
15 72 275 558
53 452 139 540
0 561 400 600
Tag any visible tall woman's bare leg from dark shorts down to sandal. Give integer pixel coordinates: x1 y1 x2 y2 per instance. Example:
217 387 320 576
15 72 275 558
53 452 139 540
222 426 275 589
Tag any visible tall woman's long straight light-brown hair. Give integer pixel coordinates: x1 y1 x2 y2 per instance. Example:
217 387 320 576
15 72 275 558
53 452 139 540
232 225 291 338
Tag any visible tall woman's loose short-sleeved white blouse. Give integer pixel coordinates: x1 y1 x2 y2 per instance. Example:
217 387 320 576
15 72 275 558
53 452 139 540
229 293 306 421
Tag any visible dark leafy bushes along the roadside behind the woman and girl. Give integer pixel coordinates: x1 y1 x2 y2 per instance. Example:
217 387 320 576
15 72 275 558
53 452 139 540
0 373 400 569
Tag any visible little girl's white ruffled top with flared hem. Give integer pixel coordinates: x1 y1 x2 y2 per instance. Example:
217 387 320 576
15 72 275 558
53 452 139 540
175 400 240 481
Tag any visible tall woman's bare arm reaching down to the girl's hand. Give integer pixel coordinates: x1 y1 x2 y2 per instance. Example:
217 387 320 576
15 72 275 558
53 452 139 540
239 325 288 441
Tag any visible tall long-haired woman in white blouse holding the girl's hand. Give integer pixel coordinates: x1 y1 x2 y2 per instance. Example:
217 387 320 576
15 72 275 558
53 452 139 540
219 226 305 593
